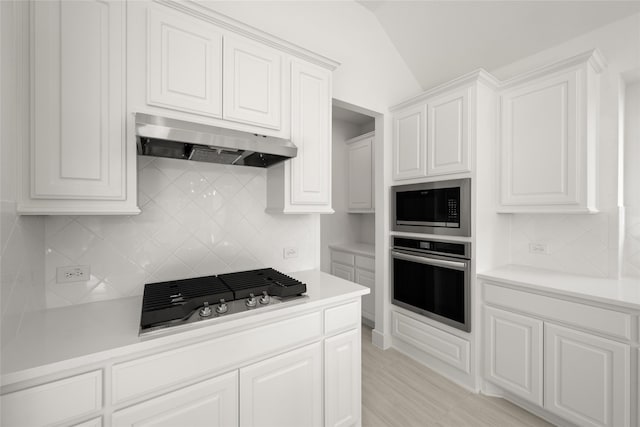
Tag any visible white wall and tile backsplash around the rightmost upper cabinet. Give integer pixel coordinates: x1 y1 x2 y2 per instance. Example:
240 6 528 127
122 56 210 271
491 14 640 277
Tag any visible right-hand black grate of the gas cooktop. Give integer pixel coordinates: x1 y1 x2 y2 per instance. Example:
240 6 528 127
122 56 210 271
218 268 307 299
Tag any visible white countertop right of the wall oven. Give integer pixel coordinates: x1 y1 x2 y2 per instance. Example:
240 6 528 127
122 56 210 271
478 265 640 310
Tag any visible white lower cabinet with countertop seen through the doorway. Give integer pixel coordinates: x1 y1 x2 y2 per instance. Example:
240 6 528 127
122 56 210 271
329 243 376 325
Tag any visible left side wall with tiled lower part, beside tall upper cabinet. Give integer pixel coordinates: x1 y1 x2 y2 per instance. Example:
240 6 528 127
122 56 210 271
0 1 44 346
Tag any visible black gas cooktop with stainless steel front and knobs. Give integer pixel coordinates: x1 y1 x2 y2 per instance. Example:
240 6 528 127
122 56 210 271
140 268 307 335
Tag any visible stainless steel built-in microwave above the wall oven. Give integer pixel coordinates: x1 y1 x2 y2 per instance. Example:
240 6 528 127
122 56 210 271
391 178 471 236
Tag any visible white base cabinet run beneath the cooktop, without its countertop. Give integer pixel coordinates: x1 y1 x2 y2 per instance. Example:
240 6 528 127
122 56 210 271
0 297 361 427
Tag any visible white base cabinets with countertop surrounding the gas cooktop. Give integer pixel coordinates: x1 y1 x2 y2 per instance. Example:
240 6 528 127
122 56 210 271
0 271 368 427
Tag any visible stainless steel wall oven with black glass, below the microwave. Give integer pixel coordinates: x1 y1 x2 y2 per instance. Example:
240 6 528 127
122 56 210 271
391 237 471 332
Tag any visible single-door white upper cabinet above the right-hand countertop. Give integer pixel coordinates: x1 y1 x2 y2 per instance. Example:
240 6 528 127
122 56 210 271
498 50 605 213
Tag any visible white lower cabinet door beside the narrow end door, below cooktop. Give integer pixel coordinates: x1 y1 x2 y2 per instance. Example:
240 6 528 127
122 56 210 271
240 343 323 427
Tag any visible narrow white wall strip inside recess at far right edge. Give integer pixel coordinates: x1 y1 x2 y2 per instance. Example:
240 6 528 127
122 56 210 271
622 81 640 277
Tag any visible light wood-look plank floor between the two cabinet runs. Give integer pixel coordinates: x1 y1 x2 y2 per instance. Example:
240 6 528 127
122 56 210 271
362 325 551 427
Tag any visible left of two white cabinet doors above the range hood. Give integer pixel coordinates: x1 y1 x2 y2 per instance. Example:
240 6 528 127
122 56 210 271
147 7 222 118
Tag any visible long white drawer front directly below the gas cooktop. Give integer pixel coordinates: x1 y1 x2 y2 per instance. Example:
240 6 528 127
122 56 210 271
112 312 322 404
